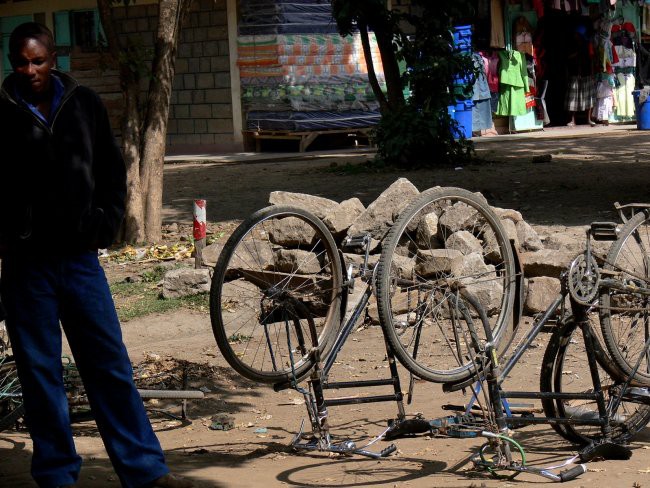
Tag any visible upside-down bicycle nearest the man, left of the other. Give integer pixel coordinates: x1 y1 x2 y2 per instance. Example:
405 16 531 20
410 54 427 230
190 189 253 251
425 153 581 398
210 188 515 457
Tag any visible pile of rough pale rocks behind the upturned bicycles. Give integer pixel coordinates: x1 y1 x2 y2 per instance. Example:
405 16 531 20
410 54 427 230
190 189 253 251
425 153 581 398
163 178 596 318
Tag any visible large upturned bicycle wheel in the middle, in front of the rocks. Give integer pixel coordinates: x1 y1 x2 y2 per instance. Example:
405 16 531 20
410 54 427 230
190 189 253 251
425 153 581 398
377 188 515 383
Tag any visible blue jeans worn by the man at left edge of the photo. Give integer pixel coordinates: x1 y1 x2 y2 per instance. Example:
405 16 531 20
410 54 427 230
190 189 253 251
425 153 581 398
1 252 169 487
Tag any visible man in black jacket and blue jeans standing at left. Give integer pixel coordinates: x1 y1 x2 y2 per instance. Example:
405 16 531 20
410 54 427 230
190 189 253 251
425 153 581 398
0 22 193 488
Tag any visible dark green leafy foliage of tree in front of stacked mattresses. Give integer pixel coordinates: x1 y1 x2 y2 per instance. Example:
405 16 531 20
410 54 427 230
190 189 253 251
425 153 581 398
332 0 477 167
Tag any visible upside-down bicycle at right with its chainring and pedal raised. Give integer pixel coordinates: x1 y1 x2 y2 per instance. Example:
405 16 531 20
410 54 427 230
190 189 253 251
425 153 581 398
378 199 650 481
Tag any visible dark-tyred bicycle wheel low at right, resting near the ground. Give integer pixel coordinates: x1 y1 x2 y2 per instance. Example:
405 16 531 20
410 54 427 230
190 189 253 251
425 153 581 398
540 314 650 445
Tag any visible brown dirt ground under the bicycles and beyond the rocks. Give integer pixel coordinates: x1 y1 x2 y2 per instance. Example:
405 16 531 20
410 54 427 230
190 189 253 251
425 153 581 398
0 130 650 488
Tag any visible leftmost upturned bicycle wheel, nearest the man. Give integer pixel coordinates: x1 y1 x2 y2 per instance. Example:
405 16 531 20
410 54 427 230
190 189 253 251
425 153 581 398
210 206 343 383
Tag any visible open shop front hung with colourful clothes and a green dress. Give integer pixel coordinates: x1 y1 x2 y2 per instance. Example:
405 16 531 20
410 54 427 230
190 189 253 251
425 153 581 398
473 0 650 135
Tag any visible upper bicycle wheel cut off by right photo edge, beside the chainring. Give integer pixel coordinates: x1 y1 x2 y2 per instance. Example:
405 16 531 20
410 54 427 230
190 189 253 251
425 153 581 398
600 211 650 386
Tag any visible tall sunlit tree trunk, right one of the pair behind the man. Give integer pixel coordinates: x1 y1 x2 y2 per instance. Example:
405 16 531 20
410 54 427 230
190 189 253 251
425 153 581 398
140 0 191 242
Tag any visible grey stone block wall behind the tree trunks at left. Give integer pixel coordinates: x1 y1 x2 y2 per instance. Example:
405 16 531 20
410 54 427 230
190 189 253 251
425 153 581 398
66 0 232 152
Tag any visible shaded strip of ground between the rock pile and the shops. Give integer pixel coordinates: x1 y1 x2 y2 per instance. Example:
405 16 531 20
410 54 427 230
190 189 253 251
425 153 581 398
164 131 650 226
